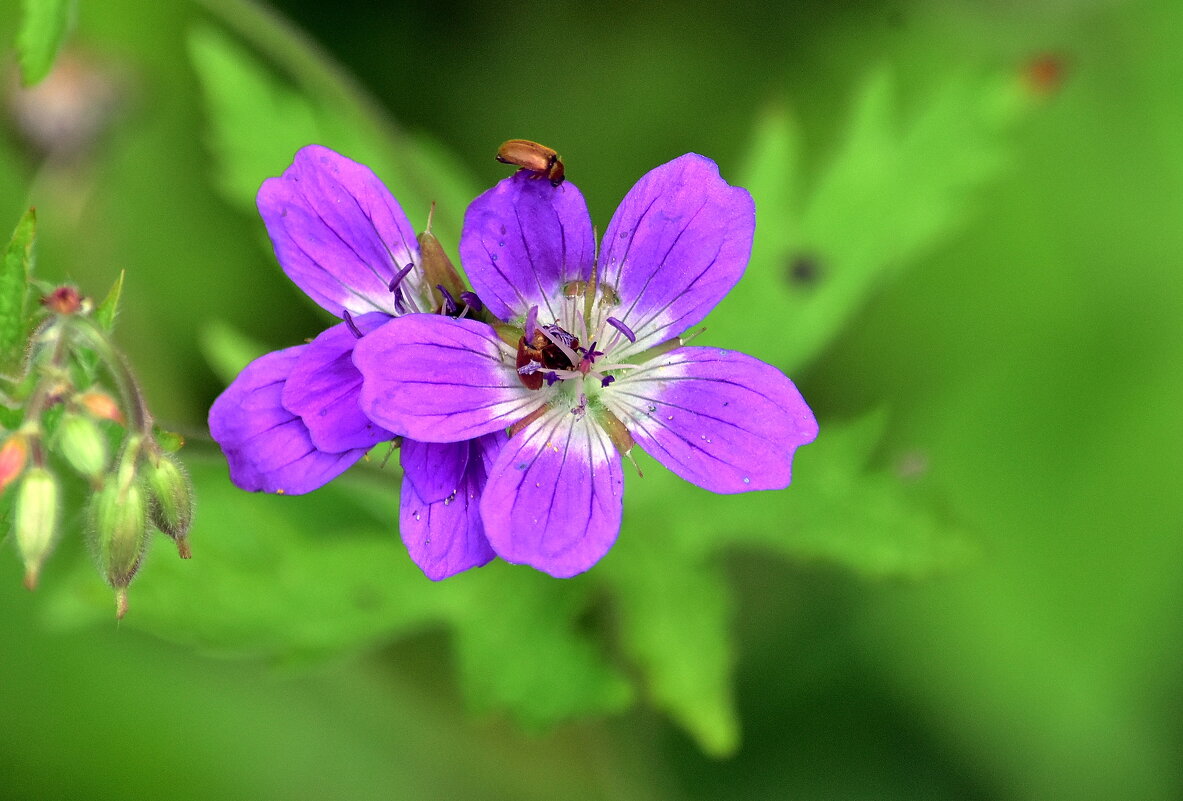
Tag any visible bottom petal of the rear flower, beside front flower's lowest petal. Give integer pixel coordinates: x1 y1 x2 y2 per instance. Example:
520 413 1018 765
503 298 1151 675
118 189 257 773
399 432 505 581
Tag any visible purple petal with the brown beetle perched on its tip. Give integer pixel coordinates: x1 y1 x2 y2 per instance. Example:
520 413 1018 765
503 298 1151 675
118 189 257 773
460 172 595 324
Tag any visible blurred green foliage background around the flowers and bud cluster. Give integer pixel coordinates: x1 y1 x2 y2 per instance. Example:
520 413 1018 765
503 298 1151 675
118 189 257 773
0 0 1183 800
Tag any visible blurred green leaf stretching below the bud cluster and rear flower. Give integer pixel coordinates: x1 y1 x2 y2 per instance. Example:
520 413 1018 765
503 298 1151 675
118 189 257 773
43 459 633 728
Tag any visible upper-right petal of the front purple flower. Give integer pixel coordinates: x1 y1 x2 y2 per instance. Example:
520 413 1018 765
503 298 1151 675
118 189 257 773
600 153 756 357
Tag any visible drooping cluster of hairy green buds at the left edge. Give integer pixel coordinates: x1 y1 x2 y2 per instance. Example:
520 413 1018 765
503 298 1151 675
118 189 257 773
0 274 193 616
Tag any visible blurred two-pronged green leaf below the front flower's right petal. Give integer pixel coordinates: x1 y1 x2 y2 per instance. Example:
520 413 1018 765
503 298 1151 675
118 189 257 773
596 414 976 756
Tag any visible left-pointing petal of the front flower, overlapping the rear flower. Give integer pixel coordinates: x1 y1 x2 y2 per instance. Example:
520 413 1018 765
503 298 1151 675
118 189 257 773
354 315 547 443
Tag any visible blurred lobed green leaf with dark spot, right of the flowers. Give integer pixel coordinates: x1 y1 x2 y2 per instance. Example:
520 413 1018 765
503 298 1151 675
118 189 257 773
710 69 1024 372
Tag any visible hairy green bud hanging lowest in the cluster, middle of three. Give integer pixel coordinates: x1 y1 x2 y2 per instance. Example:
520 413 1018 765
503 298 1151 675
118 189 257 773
90 477 148 601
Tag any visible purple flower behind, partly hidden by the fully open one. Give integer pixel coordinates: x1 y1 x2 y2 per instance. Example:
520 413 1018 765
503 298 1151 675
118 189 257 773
209 144 505 579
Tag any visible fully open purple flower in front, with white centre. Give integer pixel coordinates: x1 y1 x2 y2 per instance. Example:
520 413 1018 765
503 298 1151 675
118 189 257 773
354 154 817 576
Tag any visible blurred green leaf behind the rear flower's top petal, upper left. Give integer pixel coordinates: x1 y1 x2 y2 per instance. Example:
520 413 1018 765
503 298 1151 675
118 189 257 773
189 27 477 257
